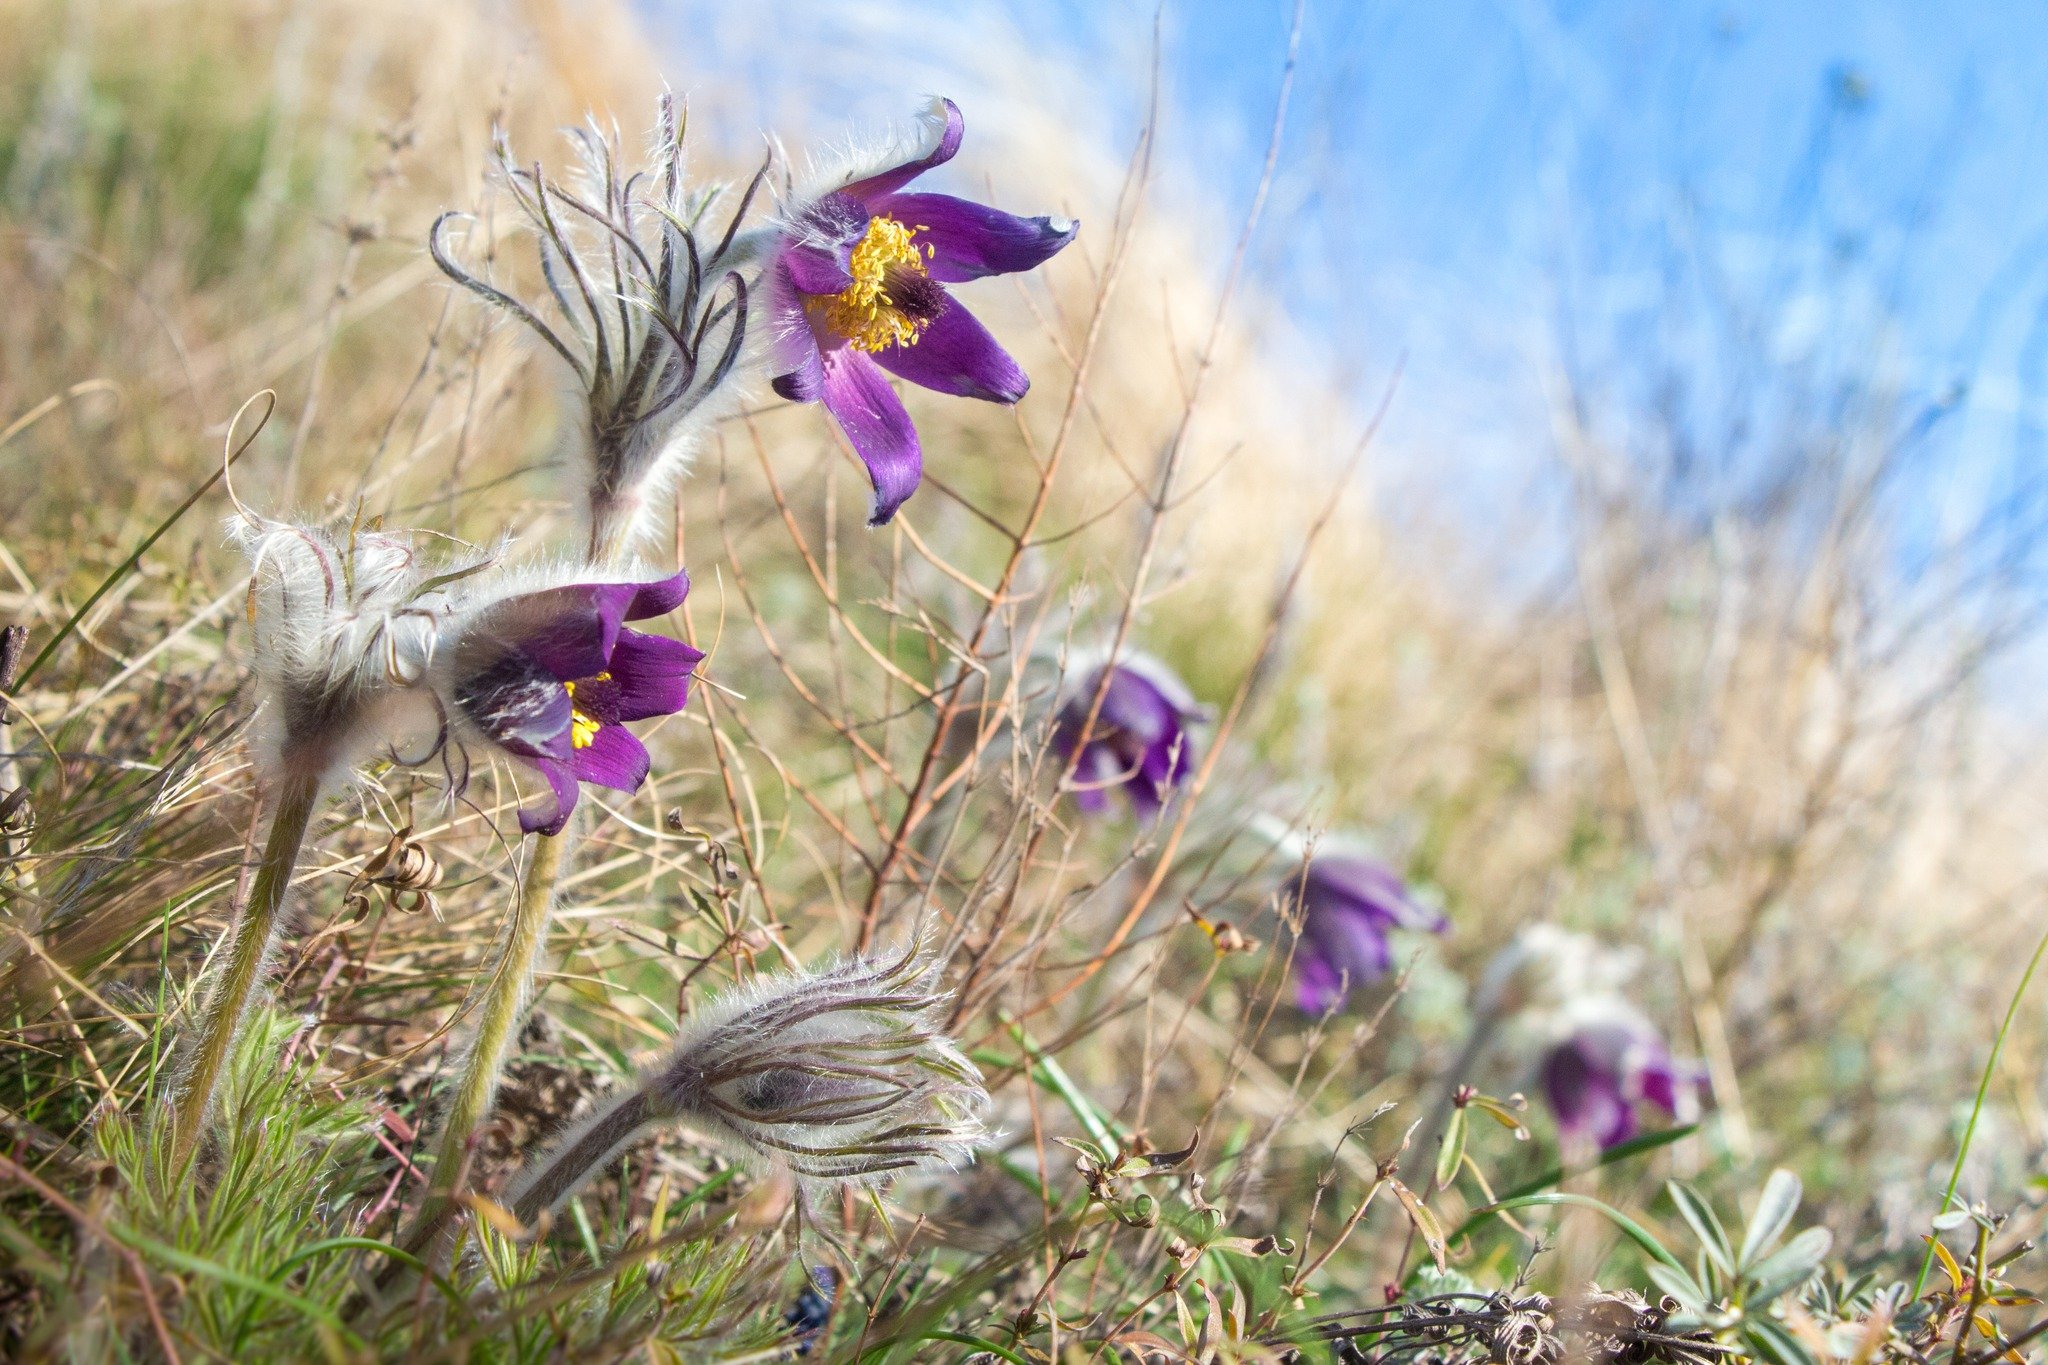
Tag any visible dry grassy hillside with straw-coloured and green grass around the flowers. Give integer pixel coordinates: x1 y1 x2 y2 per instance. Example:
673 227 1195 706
0 0 2048 1359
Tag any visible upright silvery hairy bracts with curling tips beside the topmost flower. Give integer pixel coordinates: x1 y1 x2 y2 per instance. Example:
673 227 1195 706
428 96 768 559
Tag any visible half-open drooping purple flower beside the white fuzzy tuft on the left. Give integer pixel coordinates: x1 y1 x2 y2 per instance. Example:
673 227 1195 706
444 571 705 835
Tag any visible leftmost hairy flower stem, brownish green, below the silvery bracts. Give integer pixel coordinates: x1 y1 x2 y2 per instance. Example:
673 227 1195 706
172 776 319 1171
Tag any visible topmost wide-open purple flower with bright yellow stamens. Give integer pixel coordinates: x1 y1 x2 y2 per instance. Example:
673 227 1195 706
768 100 1079 526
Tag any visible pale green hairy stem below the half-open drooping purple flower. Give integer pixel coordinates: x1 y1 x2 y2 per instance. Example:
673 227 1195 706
408 823 573 1240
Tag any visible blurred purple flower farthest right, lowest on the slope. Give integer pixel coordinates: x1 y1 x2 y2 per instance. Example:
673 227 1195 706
1542 1005 1706 1150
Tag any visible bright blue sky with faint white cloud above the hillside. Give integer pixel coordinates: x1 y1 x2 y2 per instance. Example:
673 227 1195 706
643 0 2048 573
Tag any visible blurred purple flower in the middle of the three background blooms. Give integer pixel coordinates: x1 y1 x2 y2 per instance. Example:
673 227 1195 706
1284 853 1450 1015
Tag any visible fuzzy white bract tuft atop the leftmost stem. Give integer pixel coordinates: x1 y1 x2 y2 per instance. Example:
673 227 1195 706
227 512 481 788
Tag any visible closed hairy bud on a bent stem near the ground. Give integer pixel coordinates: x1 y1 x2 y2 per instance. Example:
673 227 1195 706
508 950 989 1222
